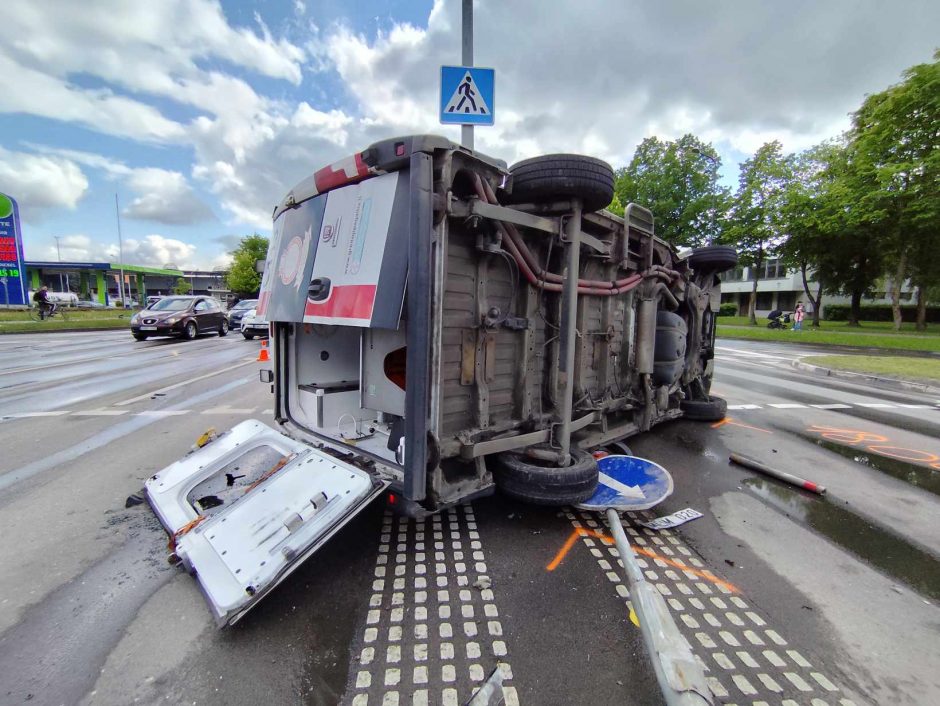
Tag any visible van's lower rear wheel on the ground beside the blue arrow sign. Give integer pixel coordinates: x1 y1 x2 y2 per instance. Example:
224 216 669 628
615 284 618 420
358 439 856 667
494 449 597 505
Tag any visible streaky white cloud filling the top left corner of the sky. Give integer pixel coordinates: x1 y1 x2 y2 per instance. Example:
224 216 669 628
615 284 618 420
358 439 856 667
0 0 305 142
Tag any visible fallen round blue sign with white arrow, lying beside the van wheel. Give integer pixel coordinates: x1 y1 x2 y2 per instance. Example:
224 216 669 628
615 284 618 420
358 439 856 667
576 456 672 512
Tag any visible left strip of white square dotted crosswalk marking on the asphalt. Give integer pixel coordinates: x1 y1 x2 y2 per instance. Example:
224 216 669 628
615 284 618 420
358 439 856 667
343 505 519 706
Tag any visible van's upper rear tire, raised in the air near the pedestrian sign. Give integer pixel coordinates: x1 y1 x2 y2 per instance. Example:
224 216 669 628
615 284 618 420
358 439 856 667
506 154 614 211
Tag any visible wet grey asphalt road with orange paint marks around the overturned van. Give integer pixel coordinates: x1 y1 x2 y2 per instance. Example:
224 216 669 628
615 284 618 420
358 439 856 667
0 332 940 706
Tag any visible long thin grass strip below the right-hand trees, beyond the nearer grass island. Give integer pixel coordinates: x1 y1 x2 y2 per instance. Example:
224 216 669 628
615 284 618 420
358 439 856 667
718 322 940 352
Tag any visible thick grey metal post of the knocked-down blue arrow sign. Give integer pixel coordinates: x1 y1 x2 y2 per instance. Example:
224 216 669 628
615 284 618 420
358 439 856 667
607 508 714 706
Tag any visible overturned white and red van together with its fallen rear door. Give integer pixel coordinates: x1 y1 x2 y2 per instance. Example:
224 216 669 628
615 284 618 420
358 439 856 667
146 135 737 624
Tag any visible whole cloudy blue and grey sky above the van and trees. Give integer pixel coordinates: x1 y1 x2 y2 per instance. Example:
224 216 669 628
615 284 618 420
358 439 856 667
0 0 940 267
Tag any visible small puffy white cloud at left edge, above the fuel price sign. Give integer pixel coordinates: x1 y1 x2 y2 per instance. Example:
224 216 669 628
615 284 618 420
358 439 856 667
0 147 88 222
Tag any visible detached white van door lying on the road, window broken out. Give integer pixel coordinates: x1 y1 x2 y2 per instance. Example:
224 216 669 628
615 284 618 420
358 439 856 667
145 420 388 627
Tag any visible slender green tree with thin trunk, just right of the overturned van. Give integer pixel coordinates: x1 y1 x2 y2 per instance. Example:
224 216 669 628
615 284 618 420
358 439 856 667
724 140 792 325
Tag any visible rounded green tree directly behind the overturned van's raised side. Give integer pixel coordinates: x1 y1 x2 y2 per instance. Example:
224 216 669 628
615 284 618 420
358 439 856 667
615 135 729 247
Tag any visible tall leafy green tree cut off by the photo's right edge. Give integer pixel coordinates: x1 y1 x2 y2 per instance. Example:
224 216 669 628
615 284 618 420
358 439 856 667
851 50 940 329
